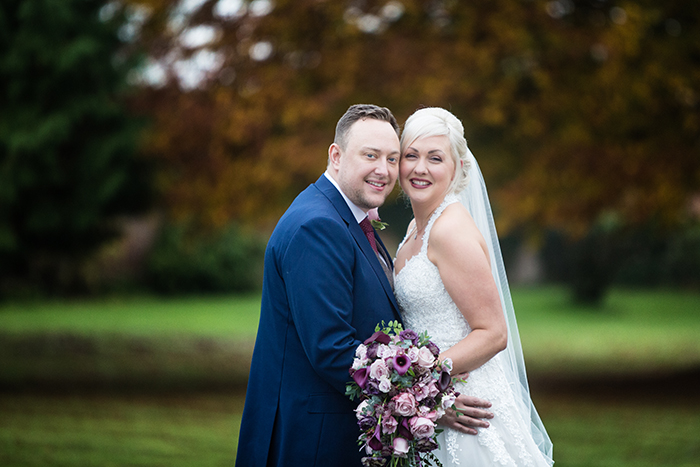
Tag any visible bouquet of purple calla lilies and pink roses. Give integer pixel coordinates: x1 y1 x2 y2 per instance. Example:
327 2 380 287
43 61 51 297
345 321 458 467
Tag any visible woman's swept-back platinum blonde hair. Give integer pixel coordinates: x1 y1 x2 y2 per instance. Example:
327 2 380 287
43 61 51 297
401 107 471 194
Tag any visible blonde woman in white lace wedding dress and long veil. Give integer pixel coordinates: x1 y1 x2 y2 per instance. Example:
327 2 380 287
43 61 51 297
394 108 553 467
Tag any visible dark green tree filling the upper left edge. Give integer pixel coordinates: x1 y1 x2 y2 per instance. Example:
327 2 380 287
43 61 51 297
0 0 150 294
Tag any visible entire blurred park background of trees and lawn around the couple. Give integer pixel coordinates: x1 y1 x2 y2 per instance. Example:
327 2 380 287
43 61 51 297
0 0 700 466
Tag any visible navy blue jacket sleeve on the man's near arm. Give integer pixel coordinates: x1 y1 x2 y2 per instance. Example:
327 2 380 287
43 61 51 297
283 218 360 394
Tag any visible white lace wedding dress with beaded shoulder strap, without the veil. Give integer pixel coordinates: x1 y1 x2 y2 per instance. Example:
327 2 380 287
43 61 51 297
394 196 550 467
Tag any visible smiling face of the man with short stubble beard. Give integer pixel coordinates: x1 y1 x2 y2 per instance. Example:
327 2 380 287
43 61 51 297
330 118 400 211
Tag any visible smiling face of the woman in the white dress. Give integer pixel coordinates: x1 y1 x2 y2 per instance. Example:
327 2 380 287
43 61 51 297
399 136 455 202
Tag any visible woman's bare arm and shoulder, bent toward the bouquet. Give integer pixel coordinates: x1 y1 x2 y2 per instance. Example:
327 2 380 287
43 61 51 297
428 205 508 374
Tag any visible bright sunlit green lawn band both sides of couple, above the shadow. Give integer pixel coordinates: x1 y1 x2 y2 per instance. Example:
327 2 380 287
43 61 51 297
0 287 700 375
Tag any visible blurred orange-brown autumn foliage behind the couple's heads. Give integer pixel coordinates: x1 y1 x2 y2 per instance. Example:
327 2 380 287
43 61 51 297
123 0 700 234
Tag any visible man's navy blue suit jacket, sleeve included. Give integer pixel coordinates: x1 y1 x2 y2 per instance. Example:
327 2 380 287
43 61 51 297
236 176 399 467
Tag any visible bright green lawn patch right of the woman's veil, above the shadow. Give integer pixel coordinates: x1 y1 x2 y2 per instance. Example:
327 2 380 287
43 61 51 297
513 287 700 376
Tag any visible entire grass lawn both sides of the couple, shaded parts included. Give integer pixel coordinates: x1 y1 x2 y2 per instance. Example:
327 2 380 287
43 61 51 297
0 287 700 467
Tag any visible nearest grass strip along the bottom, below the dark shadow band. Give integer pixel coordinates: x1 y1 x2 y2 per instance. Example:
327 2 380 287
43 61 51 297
0 394 700 467
